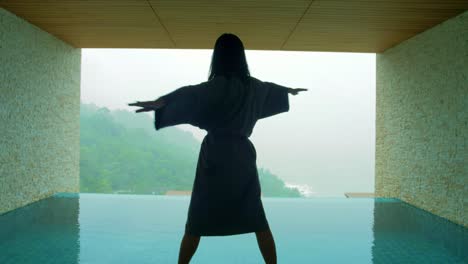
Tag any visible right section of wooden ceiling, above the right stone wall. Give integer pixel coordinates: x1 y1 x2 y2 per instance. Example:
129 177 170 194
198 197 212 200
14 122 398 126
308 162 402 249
283 0 468 52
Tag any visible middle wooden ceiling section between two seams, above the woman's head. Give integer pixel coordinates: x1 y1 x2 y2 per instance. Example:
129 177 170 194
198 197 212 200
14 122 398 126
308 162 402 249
150 0 310 50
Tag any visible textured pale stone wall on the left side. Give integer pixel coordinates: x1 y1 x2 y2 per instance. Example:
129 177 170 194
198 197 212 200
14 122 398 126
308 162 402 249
0 8 81 213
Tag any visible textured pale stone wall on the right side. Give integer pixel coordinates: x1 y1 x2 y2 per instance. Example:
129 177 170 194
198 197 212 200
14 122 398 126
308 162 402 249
375 12 468 226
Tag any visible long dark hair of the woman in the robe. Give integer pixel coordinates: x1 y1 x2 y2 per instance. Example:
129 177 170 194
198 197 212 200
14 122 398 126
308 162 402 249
208 33 250 81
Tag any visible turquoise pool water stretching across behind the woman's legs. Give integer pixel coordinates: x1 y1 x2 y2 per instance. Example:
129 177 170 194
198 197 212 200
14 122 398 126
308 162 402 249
0 194 468 264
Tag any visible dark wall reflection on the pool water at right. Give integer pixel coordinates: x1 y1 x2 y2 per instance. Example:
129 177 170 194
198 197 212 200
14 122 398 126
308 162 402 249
372 199 468 263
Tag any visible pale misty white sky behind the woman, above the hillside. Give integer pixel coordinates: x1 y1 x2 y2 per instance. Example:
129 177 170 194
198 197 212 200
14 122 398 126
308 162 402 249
81 49 375 196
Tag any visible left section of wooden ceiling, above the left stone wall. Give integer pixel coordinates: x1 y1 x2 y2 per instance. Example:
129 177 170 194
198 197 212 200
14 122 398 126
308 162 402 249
0 0 174 48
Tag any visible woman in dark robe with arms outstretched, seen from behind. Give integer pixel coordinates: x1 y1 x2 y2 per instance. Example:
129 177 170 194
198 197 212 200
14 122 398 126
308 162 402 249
129 34 307 263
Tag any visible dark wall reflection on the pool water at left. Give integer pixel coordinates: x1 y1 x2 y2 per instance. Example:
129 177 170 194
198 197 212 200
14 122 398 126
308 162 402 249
0 195 80 264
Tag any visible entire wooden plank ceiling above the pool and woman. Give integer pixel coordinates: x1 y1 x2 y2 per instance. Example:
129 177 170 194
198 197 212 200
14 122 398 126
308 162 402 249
0 0 468 52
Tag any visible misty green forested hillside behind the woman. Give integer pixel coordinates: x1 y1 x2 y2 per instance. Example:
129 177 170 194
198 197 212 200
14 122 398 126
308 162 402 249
80 104 301 197
